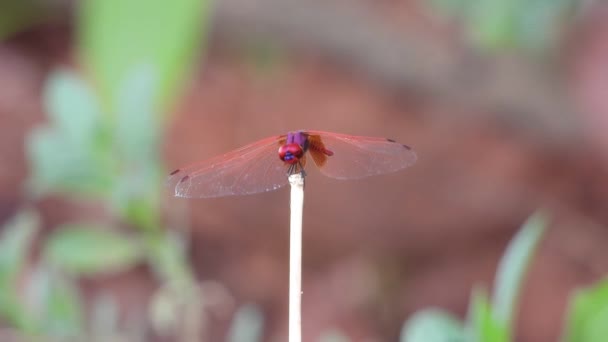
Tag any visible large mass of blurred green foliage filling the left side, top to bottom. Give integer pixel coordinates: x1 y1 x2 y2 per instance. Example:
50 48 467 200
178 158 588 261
0 0 238 341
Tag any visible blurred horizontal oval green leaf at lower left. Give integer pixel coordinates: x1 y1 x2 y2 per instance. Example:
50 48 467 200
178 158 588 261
45 224 143 275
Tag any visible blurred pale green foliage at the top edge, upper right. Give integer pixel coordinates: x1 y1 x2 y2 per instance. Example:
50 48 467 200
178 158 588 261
430 0 582 52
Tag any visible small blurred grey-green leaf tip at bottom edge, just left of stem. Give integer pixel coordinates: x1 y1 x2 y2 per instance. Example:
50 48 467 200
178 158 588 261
228 304 264 342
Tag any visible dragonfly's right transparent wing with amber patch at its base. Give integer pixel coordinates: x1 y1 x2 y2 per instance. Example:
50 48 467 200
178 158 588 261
307 131 416 179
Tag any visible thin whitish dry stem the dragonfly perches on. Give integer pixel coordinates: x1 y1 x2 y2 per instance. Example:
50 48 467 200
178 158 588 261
289 173 304 342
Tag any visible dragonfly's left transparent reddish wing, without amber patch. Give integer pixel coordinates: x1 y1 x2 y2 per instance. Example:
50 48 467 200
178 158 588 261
167 136 288 198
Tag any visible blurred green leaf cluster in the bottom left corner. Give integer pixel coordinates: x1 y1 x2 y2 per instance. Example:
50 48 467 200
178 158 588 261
0 209 84 337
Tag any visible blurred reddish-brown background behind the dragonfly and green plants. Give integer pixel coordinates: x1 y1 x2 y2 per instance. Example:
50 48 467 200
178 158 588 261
0 0 608 342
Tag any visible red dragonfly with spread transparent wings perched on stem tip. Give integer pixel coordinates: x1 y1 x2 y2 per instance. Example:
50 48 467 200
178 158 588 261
167 130 416 198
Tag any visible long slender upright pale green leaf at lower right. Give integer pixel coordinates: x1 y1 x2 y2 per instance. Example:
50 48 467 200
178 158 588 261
492 212 548 329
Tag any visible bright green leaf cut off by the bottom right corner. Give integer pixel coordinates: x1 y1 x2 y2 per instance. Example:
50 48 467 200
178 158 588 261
564 279 608 342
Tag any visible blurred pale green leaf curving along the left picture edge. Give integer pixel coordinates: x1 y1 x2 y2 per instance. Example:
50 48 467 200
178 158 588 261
0 210 40 332
